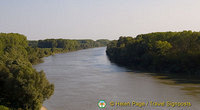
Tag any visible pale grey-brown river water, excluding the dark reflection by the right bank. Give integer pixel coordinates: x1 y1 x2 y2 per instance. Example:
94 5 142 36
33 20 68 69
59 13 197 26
34 47 200 110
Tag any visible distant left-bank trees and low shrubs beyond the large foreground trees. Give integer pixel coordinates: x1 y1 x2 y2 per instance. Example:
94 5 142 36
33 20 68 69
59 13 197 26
27 39 110 64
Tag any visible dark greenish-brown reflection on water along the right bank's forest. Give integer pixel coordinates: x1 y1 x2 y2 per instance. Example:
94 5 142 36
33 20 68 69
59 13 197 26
107 56 200 100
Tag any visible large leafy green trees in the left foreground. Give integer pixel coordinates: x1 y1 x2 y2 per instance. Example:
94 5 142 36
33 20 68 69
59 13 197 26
0 33 54 110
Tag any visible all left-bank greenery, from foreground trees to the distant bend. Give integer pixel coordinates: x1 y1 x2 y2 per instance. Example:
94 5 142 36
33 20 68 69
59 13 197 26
0 33 109 110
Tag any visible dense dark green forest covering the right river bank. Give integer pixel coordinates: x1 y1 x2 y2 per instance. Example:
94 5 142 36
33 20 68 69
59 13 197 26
106 31 200 75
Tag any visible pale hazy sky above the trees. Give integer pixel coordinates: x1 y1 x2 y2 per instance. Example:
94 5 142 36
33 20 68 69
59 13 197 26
0 0 200 40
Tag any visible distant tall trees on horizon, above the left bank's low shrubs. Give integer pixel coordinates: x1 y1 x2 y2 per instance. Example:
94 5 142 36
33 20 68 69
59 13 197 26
29 39 109 48
